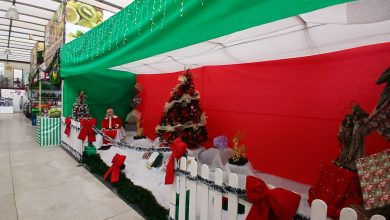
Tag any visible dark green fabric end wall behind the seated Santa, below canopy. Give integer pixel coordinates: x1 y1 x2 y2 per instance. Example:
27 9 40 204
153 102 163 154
63 70 135 127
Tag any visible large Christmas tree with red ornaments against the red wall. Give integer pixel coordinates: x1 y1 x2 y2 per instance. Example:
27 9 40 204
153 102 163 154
156 70 207 149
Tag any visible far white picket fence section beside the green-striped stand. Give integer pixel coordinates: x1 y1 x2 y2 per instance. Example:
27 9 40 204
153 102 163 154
61 117 84 160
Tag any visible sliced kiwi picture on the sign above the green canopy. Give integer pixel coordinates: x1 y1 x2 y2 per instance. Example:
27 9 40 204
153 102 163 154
66 0 103 28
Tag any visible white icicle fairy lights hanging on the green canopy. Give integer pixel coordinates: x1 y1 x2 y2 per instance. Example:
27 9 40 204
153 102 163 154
66 0 204 65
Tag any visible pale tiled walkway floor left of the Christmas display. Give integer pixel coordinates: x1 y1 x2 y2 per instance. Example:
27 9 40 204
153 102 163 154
0 114 143 220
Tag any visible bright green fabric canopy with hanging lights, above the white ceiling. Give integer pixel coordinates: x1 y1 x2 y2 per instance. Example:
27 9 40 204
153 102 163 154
61 0 351 77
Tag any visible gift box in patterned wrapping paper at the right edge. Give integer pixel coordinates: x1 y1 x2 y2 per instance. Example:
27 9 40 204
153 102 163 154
356 150 390 210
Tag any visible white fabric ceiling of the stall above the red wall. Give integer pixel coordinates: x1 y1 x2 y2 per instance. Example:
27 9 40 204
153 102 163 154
111 0 390 74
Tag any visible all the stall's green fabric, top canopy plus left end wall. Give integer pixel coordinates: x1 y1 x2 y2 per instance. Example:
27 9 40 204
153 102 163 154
61 0 351 124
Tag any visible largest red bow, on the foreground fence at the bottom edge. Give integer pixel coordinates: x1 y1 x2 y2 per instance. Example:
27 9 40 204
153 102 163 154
246 176 301 220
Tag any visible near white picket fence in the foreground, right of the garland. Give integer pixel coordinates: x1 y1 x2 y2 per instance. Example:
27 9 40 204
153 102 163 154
173 157 386 220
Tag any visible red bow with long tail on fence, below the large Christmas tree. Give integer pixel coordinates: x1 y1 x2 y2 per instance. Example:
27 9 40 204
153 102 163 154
165 138 187 184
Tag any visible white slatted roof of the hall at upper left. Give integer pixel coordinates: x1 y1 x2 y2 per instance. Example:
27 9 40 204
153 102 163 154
0 0 133 62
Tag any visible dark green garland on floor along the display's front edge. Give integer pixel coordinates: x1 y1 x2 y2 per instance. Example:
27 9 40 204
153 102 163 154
83 154 168 220
